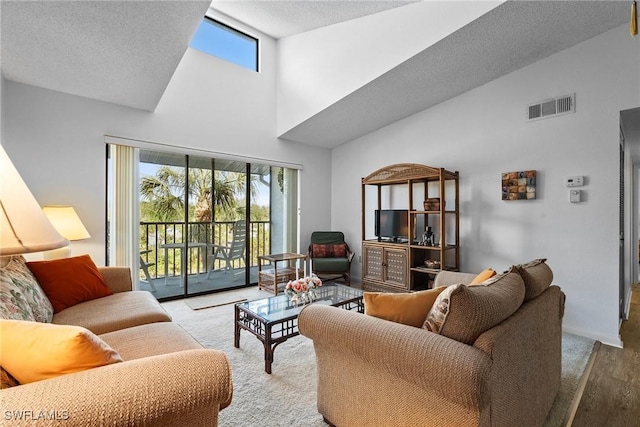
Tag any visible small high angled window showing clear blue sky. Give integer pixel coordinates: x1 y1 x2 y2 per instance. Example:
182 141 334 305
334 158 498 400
189 18 258 71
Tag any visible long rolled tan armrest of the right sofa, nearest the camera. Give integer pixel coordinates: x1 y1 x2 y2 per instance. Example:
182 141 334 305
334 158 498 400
298 304 491 409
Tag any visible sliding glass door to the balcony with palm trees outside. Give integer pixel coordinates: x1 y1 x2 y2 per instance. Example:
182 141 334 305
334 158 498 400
108 149 297 300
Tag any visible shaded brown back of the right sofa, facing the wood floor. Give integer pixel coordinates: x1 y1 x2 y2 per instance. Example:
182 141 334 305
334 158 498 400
473 285 564 426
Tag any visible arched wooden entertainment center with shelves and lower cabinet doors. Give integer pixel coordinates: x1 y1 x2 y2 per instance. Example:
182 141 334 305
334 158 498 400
362 163 460 292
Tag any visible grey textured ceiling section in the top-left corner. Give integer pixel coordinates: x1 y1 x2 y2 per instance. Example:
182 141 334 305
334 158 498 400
0 1 210 111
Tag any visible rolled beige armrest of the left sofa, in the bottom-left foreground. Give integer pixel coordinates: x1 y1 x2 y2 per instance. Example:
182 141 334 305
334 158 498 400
2 349 232 426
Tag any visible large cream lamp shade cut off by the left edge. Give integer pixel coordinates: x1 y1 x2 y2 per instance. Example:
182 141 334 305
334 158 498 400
0 146 69 255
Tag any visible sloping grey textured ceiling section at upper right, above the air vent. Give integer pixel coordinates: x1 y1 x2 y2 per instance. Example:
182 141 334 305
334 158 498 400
280 1 629 148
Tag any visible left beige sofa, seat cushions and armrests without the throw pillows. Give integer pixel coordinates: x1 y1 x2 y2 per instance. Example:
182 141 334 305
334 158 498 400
0 267 232 426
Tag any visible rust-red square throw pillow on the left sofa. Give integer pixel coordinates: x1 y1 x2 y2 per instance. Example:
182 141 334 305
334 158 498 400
27 255 113 313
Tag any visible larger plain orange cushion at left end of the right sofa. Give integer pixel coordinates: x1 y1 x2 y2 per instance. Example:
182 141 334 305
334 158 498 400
363 286 446 328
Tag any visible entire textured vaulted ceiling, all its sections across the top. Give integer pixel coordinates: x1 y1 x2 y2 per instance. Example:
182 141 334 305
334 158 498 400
0 0 630 147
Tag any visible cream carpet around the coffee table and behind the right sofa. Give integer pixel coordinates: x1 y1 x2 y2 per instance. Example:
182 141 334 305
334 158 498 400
162 288 594 427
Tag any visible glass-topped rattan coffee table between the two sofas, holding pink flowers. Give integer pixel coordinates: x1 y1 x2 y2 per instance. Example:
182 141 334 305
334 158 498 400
233 283 364 374
